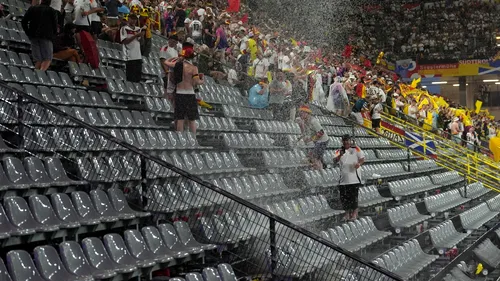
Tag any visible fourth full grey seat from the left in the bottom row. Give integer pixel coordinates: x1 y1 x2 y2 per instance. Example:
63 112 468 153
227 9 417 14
82 237 137 273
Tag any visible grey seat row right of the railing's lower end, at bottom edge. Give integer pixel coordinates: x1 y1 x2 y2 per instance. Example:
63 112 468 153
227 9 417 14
373 239 439 280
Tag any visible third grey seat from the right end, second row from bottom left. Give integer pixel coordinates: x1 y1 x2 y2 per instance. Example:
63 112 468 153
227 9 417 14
71 191 105 225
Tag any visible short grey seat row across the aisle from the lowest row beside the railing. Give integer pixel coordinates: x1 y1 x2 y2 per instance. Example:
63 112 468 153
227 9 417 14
429 220 469 248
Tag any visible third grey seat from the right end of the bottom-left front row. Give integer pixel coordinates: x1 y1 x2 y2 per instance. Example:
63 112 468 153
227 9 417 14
142 226 189 259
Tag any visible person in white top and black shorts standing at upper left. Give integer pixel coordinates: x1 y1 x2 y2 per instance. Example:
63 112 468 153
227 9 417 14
120 14 144 82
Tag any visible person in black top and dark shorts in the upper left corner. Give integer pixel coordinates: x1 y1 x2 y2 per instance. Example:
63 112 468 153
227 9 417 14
21 0 57 70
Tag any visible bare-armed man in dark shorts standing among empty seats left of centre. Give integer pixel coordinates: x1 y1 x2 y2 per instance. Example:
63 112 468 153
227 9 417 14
165 42 204 135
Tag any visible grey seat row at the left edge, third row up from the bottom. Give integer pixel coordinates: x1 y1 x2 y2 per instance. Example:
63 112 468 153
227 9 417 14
0 156 86 191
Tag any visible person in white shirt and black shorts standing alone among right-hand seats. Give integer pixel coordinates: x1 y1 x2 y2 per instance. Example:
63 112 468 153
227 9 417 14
334 135 365 221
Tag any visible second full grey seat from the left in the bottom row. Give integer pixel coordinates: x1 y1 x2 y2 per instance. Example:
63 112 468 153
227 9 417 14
33 246 94 281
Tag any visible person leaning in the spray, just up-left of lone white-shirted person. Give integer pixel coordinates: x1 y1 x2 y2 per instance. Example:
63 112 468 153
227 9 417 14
297 105 329 170
